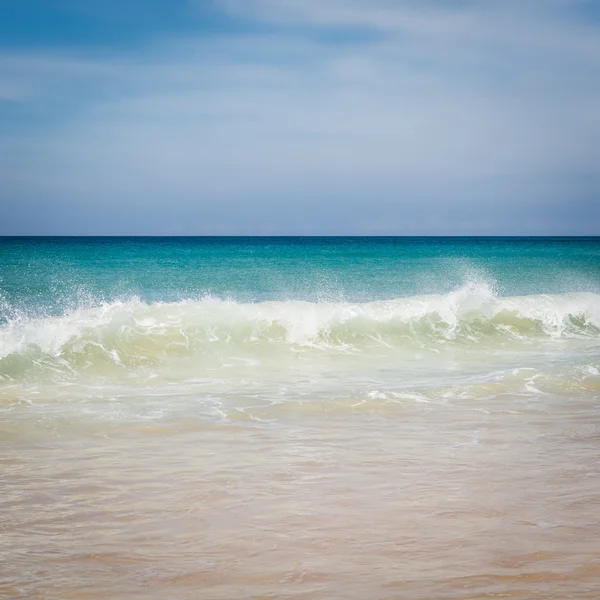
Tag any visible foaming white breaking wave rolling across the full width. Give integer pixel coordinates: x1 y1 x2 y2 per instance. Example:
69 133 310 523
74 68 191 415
0 283 600 379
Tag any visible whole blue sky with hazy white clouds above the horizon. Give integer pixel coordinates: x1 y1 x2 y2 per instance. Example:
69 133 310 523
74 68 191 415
0 0 600 235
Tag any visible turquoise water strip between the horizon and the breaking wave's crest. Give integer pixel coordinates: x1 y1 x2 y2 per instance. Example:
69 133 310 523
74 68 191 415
0 237 600 318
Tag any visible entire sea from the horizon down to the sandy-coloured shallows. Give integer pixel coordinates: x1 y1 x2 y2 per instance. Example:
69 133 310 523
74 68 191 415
0 237 600 600
